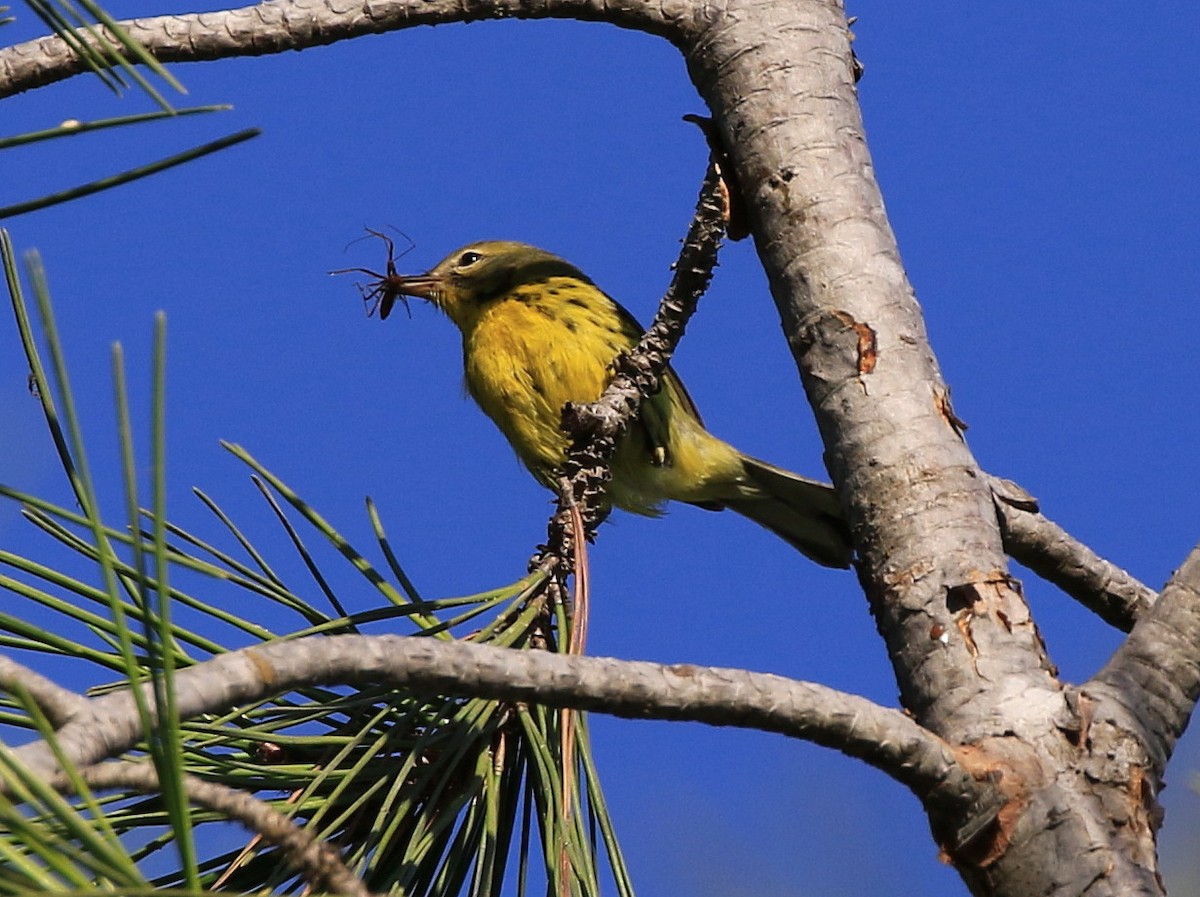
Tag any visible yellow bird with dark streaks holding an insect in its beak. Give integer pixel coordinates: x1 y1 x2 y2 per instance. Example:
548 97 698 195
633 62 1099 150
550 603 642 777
379 240 852 567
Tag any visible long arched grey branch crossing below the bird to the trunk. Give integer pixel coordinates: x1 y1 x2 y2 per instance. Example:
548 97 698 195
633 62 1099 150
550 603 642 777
7 636 988 825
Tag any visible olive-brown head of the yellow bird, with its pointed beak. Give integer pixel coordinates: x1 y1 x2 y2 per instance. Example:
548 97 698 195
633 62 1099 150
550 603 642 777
389 240 592 330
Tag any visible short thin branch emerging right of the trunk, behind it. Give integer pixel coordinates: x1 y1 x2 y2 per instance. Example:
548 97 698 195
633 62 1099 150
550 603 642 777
988 476 1158 632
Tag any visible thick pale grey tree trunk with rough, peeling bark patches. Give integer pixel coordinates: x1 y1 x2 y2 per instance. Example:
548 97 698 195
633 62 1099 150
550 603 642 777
684 0 1196 897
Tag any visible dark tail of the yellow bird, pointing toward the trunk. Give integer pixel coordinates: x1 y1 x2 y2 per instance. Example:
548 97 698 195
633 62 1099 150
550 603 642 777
721 454 852 567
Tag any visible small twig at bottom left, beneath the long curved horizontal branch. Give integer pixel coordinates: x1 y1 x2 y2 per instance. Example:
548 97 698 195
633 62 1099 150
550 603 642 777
65 761 371 897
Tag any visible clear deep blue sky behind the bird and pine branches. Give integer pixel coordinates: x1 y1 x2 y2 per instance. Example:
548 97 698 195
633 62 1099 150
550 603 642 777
0 0 1200 897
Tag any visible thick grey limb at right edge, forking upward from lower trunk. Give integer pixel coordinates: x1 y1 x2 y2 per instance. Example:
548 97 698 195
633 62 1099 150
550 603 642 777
1082 546 1200 775
